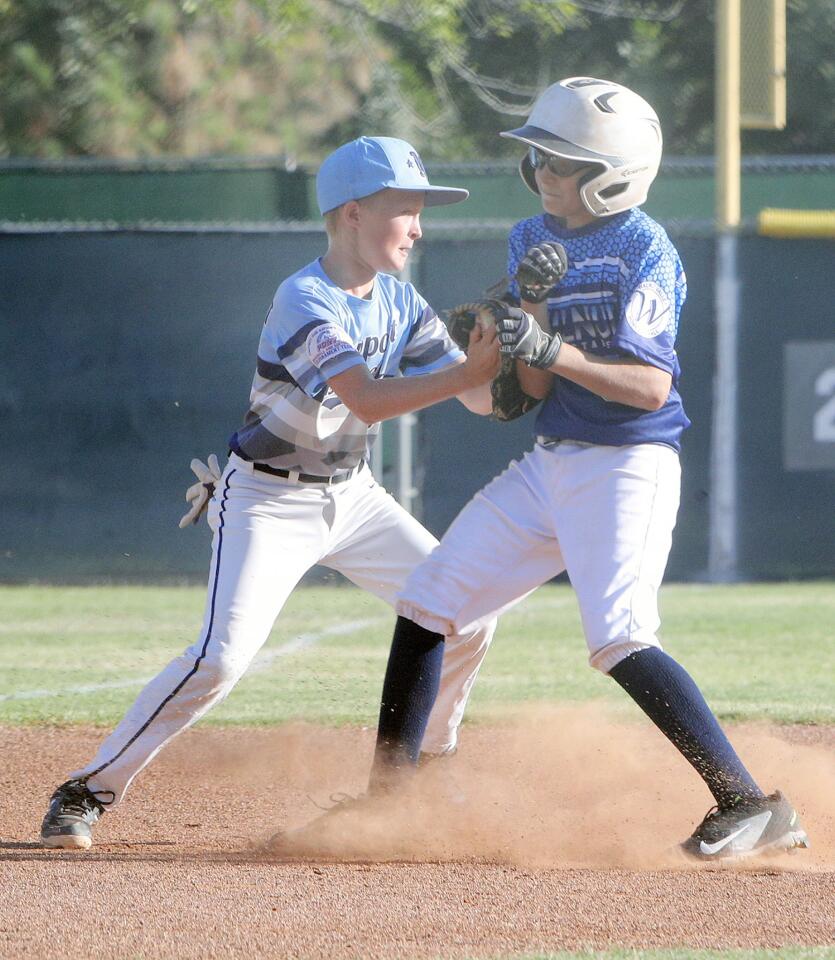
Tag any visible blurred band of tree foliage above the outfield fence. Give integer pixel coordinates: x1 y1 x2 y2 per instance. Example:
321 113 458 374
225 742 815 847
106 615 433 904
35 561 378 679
0 0 835 160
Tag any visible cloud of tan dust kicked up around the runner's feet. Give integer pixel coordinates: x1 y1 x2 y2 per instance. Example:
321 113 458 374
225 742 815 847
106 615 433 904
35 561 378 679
204 705 835 871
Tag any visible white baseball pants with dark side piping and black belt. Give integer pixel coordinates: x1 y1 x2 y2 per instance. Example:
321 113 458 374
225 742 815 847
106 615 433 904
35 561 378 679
71 454 495 806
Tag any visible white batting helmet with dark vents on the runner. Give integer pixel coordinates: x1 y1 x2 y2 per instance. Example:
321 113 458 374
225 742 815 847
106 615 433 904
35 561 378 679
501 77 662 217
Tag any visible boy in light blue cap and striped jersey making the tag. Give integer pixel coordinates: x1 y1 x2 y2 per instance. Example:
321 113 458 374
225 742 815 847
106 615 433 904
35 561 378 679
41 137 500 849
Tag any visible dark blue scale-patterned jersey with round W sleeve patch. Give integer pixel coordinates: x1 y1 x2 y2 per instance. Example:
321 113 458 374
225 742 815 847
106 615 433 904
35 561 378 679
508 208 690 450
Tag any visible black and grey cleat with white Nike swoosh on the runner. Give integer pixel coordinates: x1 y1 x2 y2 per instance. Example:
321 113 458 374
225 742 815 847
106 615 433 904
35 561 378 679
681 790 809 861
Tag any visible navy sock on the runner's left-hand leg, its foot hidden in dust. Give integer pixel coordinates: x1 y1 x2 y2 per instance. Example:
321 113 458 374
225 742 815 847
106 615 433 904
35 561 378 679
369 617 444 793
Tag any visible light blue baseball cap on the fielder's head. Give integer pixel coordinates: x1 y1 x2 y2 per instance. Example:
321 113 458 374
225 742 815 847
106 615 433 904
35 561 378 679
316 137 470 214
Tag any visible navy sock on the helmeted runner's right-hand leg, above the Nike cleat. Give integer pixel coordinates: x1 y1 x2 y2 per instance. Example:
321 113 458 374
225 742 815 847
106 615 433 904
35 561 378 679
609 647 763 807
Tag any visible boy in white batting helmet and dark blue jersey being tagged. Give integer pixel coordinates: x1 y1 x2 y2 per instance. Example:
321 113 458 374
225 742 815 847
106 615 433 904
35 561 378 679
360 77 808 860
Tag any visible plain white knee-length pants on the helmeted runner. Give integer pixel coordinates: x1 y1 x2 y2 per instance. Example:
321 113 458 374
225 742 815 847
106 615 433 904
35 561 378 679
397 442 681 673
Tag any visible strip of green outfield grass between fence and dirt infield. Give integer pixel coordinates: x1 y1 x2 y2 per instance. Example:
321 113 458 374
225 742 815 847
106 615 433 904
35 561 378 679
0 582 835 726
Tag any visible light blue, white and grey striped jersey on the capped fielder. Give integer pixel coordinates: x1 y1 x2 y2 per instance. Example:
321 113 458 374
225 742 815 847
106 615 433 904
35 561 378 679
229 260 464 476
